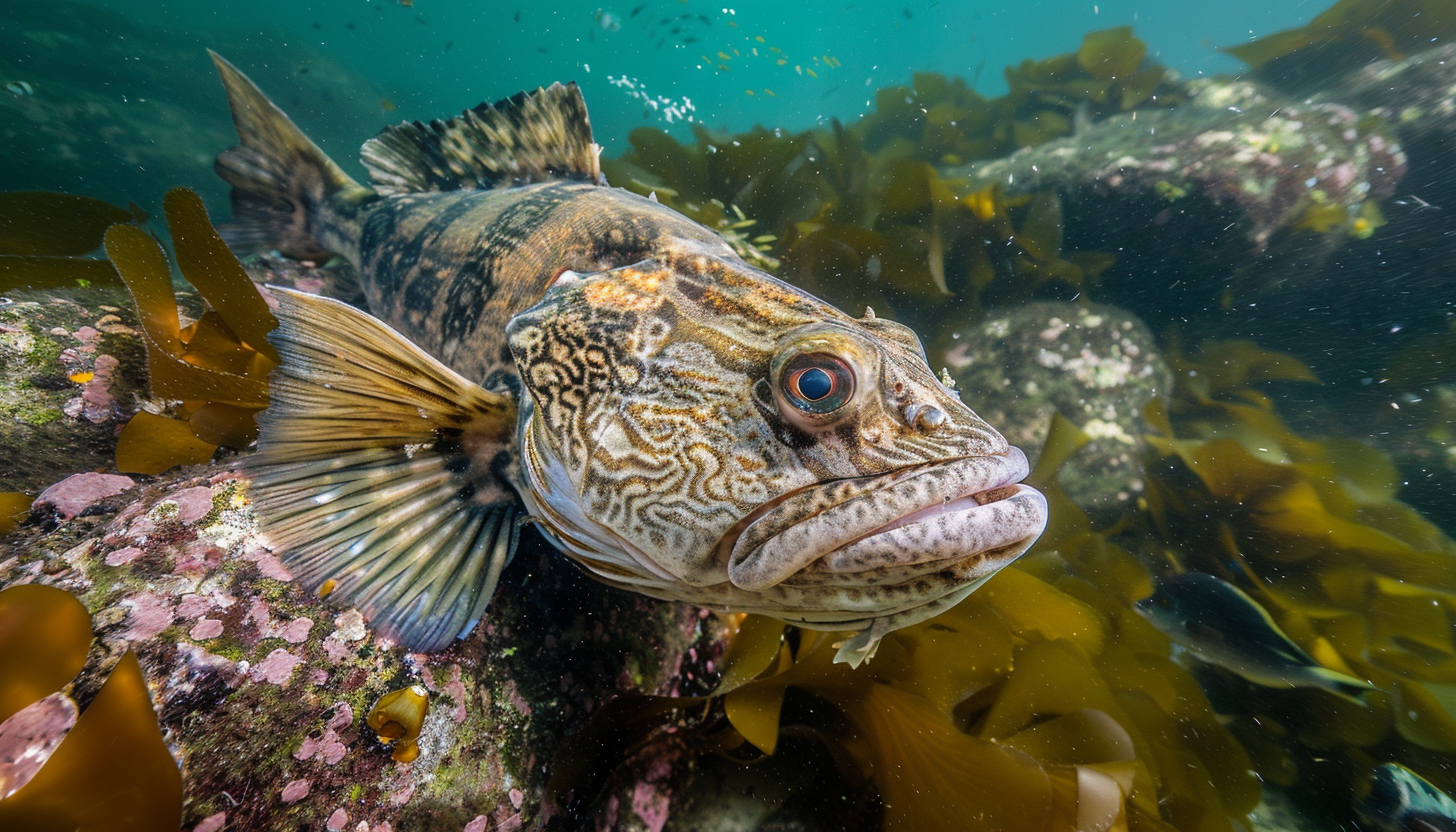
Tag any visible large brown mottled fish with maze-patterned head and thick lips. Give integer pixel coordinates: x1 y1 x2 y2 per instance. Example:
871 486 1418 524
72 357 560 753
214 55 1047 662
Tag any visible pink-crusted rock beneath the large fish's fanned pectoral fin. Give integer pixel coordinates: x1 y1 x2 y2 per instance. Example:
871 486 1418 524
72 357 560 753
0 463 724 832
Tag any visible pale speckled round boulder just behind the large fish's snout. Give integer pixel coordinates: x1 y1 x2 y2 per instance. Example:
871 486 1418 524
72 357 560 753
932 302 1172 517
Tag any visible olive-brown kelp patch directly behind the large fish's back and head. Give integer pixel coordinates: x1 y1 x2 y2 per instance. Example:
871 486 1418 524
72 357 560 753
604 122 1112 322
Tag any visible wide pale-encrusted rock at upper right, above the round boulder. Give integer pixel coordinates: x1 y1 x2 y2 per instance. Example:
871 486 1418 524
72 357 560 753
946 77 1406 306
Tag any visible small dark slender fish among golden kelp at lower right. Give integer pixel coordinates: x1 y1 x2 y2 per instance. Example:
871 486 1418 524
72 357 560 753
1136 573 1379 704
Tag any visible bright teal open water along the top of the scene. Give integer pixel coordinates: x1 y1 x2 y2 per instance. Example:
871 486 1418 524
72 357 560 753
108 0 1322 148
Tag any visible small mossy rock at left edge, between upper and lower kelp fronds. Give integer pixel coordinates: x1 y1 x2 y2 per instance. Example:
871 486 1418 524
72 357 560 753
0 289 147 494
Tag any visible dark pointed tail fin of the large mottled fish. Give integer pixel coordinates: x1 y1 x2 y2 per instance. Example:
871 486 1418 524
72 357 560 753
208 50 374 261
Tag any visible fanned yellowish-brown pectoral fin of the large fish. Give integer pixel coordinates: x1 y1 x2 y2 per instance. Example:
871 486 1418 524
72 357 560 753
243 289 521 651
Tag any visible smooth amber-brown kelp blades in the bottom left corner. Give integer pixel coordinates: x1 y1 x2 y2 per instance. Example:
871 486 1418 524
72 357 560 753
0 584 182 832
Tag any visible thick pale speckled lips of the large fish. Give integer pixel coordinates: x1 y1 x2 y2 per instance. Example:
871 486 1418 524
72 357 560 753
716 447 1045 590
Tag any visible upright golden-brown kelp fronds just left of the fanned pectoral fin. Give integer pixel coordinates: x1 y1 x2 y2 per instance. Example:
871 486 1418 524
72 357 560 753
106 188 278 474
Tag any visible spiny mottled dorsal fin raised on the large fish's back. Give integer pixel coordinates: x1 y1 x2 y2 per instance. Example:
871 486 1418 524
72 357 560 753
363 83 607 195
